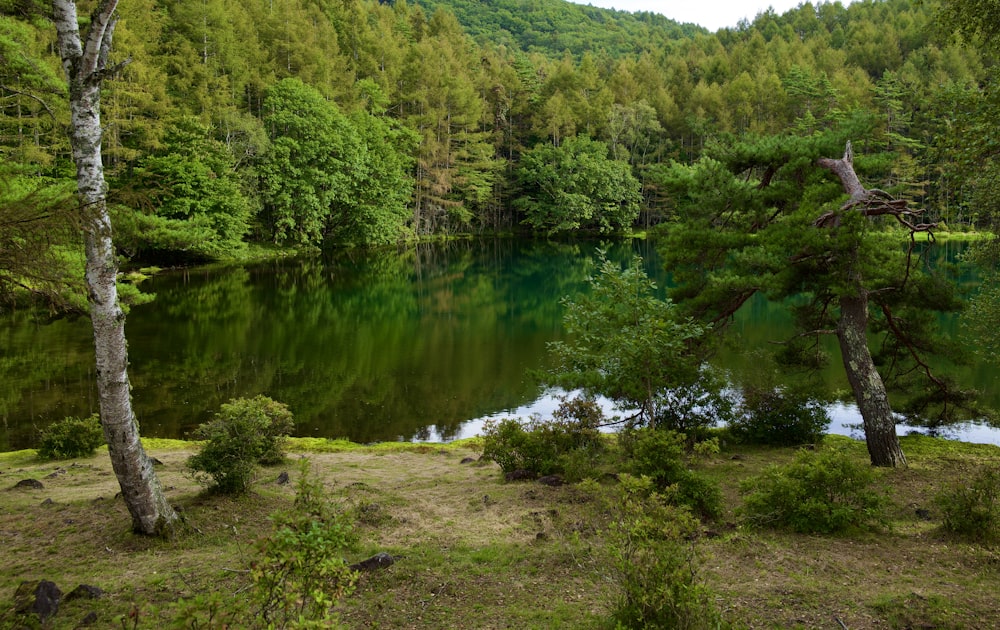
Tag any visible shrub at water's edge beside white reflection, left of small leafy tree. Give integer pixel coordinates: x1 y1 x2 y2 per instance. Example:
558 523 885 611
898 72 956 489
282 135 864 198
483 398 604 476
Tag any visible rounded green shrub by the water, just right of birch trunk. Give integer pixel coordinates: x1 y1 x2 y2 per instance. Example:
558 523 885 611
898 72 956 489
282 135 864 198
188 396 294 494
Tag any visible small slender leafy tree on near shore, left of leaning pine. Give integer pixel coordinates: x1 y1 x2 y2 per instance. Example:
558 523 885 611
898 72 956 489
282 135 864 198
545 254 706 425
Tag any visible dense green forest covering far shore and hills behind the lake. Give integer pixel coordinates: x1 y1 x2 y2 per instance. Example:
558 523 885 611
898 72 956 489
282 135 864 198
0 0 1000 293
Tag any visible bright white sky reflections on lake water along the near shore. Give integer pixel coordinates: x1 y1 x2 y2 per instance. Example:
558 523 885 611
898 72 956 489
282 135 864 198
426 391 1000 446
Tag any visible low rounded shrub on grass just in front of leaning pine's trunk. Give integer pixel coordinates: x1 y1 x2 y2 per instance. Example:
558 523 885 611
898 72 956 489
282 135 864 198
740 450 889 534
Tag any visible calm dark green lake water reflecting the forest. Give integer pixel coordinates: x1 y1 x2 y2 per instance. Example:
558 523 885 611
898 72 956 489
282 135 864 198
0 240 1000 450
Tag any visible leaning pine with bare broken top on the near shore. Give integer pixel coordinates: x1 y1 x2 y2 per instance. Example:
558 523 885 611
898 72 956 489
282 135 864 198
659 132 970 467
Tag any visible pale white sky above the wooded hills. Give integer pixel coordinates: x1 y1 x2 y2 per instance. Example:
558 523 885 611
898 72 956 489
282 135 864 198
573 0 850 33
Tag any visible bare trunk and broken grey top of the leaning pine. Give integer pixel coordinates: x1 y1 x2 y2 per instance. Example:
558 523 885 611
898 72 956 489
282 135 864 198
818 142 906 467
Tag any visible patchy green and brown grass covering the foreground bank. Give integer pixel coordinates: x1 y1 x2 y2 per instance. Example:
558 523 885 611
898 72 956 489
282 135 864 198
0 436 1000 629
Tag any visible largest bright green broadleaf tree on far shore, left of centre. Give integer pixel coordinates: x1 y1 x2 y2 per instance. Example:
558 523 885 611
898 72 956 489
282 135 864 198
259 79 416 245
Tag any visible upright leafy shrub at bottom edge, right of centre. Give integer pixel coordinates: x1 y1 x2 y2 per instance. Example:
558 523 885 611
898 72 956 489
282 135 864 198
609 474 722 629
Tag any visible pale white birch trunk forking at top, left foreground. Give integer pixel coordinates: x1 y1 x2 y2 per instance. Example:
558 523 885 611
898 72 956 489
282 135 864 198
52 0 177 536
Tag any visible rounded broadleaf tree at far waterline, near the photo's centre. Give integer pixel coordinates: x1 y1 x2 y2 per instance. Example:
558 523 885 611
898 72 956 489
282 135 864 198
515 136 640 234
